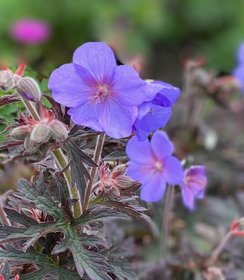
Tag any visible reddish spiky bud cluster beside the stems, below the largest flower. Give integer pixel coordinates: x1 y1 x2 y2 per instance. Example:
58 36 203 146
94 163 140 197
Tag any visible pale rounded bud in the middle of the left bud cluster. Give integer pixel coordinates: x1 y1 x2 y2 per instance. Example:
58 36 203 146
30 123 51 144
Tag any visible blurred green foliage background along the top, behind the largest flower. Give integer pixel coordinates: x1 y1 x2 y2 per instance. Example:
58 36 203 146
0 0 244 84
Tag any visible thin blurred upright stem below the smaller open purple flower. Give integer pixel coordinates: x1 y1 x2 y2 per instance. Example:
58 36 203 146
162 185 175 258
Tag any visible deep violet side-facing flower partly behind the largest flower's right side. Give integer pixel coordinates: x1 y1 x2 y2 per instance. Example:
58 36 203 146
134 81 180 141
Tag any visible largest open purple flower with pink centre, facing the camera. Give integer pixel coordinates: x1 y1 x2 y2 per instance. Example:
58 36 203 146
49 43 158 138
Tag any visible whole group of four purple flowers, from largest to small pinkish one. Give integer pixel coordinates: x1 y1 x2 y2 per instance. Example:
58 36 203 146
48 43 206 209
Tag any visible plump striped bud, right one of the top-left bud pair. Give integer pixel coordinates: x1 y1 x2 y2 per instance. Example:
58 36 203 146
16 77 42 101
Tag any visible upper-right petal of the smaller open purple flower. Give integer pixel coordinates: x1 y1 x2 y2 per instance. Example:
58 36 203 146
151 131 174 160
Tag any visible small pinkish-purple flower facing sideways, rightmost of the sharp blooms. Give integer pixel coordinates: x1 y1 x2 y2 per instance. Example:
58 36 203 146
180 165 207 210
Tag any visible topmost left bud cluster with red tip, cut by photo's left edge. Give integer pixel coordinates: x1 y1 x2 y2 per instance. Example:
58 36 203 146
0 64 42 102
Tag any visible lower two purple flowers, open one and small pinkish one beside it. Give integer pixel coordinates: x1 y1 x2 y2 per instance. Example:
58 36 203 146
126 131 207 207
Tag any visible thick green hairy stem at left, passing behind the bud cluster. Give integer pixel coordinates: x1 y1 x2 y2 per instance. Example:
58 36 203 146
22 98 81 218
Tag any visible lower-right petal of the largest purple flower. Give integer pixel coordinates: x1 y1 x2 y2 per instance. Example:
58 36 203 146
99 99 138 139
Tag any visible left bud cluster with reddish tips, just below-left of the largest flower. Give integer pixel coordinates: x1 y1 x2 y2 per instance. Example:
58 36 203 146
10 106 68 152
